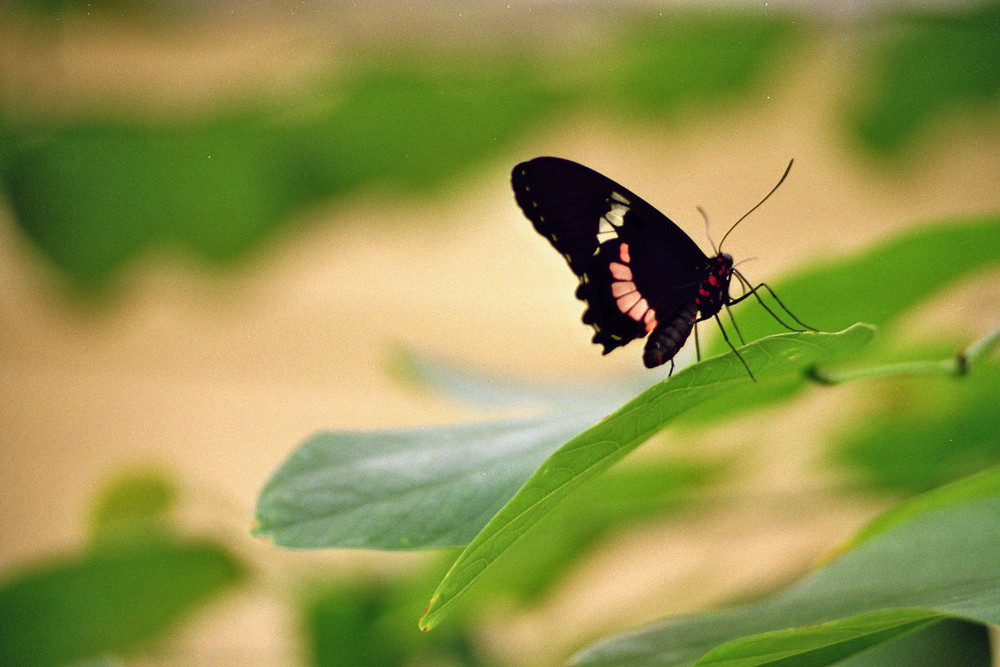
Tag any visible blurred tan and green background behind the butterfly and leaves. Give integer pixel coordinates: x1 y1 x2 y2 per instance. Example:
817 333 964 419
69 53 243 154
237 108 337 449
0 0 1000 665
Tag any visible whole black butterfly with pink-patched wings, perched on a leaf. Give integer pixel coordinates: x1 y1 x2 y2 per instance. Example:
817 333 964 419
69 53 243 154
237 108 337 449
511 157 812 378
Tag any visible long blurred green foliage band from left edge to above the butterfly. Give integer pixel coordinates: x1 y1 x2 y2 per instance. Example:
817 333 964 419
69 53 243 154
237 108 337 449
0 9 792 287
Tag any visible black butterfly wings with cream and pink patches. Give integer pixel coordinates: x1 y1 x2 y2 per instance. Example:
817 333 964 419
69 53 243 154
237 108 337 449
511 157 708 354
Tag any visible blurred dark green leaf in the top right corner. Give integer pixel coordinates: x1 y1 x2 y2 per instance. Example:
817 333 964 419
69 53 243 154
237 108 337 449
848 2 1000 153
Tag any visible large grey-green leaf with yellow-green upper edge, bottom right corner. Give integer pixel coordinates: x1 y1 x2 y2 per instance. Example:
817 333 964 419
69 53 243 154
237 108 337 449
575 479 1000 665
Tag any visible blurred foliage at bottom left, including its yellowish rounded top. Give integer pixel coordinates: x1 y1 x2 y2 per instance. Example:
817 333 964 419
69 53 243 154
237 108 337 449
0 473 245 667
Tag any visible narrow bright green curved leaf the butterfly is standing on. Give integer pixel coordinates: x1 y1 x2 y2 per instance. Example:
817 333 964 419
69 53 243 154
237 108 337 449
421 324 874 629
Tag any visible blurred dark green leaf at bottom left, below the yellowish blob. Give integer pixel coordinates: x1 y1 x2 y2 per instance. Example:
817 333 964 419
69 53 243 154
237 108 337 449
0 541 242 667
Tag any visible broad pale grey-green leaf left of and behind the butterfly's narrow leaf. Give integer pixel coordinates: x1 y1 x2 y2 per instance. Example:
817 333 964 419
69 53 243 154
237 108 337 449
253 414 594 549
